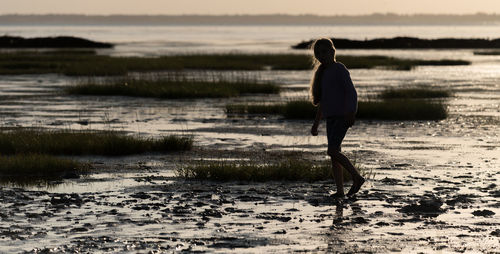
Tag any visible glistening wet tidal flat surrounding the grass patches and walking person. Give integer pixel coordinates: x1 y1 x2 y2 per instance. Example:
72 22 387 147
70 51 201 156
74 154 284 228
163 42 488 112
0 47 500 253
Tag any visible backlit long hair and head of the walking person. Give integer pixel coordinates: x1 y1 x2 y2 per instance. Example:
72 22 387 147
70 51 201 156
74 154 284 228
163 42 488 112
309 38 335 106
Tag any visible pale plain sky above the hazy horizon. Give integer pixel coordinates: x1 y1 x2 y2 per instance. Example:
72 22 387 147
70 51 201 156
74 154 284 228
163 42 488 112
0 0 500 15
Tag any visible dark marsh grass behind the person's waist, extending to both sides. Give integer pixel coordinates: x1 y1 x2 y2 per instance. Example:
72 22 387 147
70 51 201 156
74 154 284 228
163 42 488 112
225 88 451 120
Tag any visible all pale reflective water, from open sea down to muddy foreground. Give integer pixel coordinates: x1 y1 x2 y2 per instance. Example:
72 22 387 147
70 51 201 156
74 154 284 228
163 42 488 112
0 23 500 252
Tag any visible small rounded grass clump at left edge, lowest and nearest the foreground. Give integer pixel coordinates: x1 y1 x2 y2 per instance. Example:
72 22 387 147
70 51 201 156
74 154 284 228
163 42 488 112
0 154 89 186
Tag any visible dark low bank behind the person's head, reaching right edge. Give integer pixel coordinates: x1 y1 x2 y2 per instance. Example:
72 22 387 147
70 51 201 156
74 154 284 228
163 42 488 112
291 37 500 49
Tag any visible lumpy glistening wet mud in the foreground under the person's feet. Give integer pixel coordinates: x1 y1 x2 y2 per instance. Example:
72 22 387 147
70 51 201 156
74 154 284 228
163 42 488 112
0 149 500 253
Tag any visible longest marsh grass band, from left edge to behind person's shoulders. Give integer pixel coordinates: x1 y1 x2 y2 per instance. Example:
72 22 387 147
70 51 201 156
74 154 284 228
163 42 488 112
0 49 470 76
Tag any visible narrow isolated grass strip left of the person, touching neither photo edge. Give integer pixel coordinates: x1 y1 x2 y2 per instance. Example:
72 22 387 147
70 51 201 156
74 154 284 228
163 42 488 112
66 78 280 99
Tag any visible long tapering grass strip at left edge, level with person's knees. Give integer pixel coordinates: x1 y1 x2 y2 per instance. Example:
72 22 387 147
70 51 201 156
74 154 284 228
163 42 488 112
0 129 193 156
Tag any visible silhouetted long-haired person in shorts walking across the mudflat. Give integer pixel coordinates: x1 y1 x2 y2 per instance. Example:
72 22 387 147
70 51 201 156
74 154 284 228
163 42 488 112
310 39 365 198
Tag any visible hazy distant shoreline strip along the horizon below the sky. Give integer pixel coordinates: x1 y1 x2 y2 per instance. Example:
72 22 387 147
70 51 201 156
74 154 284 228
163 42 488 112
0 13 500 26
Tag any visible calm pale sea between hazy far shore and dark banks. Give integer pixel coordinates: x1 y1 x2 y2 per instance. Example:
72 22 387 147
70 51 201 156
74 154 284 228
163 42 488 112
0 25 500 55
